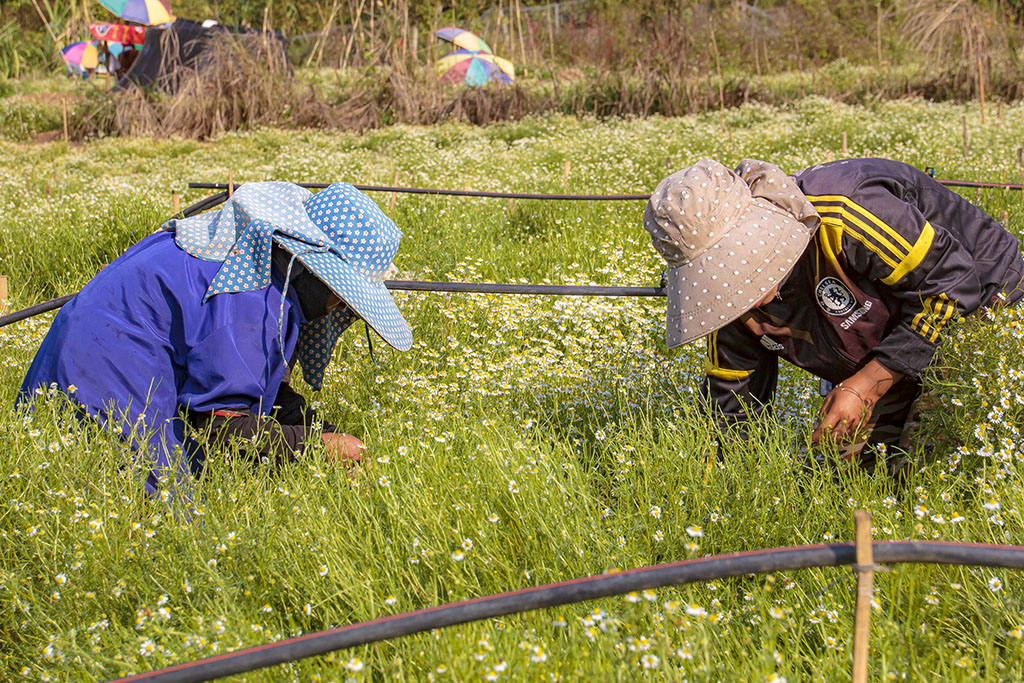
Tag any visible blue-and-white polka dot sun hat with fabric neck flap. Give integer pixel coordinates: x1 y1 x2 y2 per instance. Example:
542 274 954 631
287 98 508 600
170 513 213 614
161 182 413 389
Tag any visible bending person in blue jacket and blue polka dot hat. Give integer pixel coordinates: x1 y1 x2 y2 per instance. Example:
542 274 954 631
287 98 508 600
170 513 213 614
18 182 412 493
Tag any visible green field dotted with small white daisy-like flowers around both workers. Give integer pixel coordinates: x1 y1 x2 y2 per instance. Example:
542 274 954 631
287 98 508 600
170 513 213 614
0 99 1024 681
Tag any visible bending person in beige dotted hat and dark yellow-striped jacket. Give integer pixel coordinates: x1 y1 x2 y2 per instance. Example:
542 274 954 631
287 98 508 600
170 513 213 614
644 159 1024 469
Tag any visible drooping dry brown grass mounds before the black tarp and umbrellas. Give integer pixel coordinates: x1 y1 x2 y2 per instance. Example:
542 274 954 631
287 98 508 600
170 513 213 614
73 26 550 139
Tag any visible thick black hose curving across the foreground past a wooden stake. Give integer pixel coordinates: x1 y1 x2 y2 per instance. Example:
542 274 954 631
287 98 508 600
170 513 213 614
105 541 1024 683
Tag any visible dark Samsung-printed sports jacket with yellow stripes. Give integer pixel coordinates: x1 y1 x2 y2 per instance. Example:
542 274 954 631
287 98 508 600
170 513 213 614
705 159 1024 423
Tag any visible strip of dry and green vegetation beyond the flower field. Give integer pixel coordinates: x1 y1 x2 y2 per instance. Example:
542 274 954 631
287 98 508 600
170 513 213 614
6 0 1024 138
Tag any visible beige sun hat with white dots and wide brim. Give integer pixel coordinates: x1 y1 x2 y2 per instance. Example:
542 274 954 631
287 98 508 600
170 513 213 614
643 159 820 348
